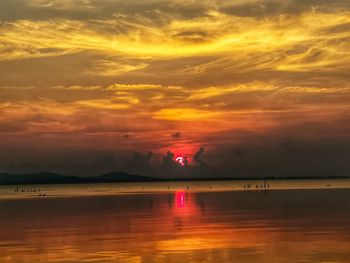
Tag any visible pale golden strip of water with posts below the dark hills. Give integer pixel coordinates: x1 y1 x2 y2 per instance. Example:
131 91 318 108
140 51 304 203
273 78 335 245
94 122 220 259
0 178 350 200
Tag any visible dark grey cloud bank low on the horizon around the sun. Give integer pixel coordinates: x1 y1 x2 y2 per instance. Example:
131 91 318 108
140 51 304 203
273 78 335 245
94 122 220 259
0 134 350 178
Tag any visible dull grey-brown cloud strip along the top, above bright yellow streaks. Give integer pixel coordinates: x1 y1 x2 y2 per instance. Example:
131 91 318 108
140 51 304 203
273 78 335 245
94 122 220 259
0 0 350 25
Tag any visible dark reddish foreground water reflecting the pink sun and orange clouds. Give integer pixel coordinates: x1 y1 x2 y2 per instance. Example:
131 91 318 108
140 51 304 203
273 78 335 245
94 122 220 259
0 186 350 262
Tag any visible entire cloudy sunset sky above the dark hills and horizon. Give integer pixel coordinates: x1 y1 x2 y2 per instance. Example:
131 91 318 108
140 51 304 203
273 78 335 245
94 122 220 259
0 0 350 177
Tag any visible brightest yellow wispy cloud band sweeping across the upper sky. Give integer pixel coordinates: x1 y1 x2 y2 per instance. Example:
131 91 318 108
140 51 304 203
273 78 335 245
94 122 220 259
0 11 350 64
